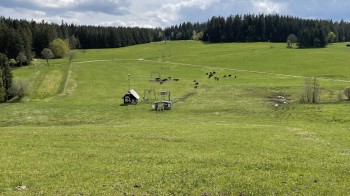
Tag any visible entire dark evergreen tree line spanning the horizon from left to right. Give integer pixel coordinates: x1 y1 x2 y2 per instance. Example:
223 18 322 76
0 14 350 65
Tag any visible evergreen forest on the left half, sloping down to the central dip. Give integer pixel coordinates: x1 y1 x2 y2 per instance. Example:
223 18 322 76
0 17 161 64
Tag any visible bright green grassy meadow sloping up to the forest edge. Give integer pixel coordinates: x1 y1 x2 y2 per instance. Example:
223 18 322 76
0 41 350 195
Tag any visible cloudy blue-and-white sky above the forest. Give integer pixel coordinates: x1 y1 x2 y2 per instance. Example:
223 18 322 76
0 0 350 27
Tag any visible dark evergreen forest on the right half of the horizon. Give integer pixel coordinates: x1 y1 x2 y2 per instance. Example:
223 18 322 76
165 14 350 48
